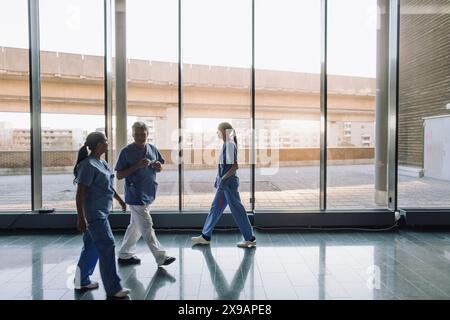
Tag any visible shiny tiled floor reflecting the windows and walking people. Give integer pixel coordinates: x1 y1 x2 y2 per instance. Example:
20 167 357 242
0 230 450 300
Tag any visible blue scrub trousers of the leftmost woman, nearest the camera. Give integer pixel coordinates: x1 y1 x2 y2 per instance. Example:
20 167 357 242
78 215 122 296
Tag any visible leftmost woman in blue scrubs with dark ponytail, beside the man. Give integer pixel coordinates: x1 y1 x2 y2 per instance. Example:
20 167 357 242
74 132 129 299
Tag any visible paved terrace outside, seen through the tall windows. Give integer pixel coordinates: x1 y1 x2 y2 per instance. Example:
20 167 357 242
0 164 450 210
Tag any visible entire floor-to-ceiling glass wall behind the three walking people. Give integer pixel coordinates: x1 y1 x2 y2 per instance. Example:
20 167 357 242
0 0 450 219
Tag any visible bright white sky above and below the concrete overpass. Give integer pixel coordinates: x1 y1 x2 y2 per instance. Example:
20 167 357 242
0 0 377 130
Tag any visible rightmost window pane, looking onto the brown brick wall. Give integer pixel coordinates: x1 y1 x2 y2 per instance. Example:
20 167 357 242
398 0 450 208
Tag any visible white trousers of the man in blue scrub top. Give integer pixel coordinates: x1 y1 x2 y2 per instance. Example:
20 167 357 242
119 205 166 265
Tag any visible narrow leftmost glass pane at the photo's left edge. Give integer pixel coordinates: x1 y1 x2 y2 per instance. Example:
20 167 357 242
0 0 31 211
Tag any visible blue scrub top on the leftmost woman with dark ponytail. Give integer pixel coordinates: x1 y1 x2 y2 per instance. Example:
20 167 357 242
75 156 114 221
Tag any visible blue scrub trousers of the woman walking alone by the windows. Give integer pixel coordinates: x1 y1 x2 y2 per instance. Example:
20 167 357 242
202 175 253 241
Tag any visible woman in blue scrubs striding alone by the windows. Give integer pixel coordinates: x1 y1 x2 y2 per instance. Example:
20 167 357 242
191 122 256 248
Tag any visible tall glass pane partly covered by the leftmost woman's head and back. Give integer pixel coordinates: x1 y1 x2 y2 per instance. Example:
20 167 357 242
39 0 105 209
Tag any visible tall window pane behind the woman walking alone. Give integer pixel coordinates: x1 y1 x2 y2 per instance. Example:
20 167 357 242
182 0 252 209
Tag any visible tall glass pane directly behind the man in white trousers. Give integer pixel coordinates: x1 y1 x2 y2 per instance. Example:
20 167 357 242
126 0 178 210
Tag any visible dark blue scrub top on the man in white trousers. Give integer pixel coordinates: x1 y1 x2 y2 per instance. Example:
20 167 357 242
115 143 164 205
